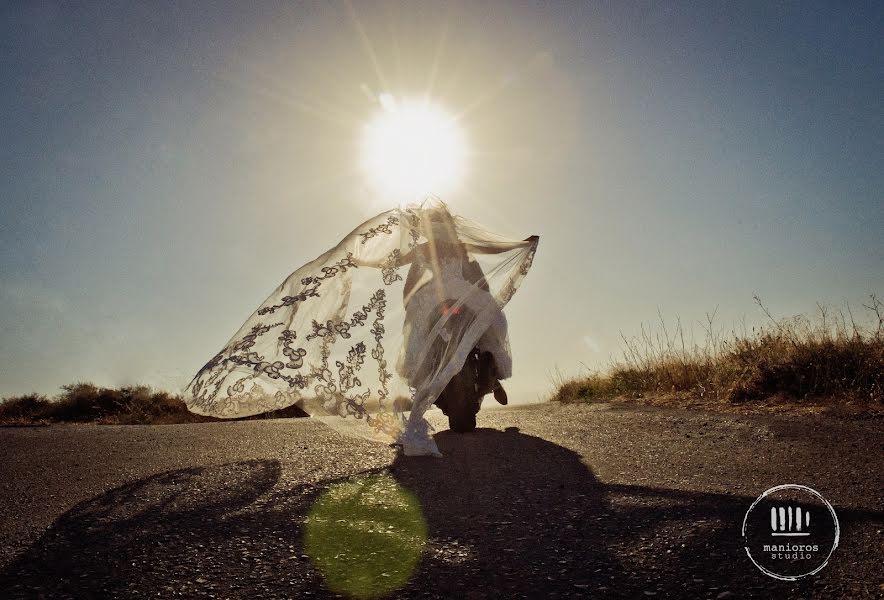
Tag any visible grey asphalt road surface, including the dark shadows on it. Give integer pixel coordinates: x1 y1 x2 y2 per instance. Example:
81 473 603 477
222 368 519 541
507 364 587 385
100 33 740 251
0 404 884 599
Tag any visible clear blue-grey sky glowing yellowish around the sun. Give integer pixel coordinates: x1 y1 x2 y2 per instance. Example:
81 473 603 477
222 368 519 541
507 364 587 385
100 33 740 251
0 0 884 400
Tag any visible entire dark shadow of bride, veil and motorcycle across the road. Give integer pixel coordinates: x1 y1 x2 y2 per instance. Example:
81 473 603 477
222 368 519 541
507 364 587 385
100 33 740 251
0 428 881 598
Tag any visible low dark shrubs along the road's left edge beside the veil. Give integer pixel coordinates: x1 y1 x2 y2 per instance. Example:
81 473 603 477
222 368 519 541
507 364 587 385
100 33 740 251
0 383 306 425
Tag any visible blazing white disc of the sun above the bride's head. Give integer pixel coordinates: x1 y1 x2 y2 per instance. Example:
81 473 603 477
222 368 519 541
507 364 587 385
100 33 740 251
362 94 466 201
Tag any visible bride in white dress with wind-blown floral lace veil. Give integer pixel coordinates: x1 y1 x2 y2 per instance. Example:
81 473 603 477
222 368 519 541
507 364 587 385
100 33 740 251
185 199 538 454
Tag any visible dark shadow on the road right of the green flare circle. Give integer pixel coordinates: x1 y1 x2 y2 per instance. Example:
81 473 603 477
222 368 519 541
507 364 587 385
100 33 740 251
394 428 868 598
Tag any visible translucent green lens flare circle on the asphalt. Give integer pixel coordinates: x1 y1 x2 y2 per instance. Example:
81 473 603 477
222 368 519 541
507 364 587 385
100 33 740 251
304 475 427 598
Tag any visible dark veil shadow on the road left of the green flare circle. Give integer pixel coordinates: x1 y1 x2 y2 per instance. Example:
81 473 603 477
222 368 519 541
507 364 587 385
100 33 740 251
0 460 320 598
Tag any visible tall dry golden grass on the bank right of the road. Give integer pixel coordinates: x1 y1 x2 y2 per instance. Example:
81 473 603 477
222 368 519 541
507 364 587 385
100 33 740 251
551 295 884 410
